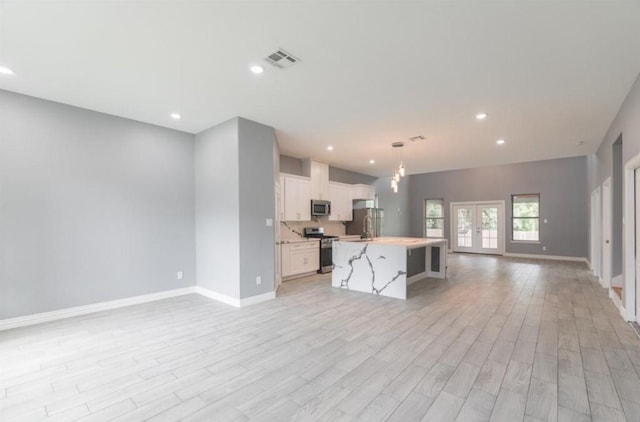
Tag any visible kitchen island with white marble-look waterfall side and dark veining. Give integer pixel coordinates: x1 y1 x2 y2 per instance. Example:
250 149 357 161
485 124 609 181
331 237 447 299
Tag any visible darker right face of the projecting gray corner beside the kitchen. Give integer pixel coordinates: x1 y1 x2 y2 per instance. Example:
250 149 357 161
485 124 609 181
238 118 278 298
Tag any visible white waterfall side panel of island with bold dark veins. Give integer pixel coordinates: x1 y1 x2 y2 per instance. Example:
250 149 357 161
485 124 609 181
331 241 407 299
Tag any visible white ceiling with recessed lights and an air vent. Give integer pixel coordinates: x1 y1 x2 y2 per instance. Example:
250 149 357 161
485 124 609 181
0 0 640 176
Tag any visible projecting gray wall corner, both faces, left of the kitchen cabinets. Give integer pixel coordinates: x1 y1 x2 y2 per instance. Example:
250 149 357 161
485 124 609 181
195 118 277 304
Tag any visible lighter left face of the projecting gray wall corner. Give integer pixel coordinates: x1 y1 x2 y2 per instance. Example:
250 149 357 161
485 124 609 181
195 119 240 298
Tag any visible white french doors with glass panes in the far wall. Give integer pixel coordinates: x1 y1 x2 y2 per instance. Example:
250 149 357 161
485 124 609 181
451 201 504 255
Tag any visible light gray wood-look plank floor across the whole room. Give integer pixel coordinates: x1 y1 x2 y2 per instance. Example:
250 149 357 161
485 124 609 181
0 255 640 422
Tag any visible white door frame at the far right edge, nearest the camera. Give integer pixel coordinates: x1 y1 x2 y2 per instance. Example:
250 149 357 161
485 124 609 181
622 150 640 321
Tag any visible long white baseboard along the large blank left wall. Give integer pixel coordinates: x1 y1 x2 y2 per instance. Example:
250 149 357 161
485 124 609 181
0 287 196 331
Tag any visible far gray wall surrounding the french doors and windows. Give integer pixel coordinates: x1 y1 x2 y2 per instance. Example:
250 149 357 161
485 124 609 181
408 156 589 257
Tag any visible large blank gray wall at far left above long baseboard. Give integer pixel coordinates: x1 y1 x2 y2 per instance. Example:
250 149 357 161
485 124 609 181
0 90 195 319
